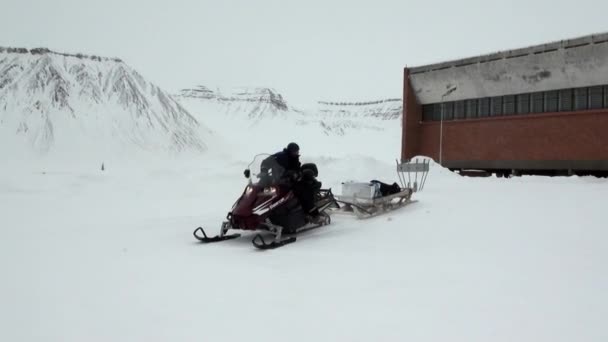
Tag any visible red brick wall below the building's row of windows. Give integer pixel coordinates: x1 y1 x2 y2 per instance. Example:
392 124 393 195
414 109 608 170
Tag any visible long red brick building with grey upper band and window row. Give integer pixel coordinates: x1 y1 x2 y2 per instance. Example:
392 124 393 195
401 33 608 174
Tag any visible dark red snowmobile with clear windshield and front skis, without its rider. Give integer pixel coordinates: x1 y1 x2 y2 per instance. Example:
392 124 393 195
193 154 339 249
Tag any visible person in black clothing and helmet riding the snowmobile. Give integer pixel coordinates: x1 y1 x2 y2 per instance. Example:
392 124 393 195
261 142 321 223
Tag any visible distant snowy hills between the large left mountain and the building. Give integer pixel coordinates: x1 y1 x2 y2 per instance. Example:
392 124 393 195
176 86 401 160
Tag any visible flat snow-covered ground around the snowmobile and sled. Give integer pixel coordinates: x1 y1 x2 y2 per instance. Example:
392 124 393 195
0 153 608 342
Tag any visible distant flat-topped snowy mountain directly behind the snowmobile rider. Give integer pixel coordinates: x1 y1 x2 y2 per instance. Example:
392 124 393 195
175 86 328 158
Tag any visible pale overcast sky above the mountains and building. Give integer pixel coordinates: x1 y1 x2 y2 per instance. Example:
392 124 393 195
0 0 608 104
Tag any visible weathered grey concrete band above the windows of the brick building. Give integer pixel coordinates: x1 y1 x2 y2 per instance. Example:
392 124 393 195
409 33 608 104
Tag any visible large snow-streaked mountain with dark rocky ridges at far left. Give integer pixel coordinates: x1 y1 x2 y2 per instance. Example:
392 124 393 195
0 48 209 156
